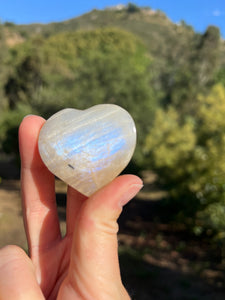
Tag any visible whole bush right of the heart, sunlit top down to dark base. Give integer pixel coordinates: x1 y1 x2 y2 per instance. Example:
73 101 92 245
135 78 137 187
144 107 198 217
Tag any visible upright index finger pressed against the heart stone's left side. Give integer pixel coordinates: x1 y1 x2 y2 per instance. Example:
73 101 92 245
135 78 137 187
19 116 60 261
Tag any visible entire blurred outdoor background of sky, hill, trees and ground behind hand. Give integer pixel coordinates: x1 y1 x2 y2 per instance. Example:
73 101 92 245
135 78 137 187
0 0 225 300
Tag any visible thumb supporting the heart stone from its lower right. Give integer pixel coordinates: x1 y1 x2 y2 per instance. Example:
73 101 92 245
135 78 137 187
60 175 143 300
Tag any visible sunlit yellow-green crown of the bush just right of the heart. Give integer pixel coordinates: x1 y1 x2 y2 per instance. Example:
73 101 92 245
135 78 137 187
145 107 196 170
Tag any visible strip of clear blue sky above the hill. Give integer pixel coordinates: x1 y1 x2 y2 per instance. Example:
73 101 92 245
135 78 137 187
0 0 225 38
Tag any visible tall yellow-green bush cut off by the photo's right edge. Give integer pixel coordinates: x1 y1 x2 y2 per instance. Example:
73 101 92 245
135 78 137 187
193 85 225 232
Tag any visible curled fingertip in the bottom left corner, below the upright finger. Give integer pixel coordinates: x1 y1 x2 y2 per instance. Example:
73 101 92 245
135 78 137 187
0 246 44 300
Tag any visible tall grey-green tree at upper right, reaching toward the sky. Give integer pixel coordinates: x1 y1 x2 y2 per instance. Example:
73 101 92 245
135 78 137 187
160 23 222 114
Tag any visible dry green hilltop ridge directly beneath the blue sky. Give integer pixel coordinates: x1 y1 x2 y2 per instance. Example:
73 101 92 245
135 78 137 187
9 8 200 56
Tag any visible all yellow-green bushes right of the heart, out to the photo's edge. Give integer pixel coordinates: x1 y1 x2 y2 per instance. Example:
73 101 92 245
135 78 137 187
145 85 225 236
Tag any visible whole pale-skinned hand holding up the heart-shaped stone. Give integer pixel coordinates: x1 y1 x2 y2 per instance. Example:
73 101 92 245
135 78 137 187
0 116 142 300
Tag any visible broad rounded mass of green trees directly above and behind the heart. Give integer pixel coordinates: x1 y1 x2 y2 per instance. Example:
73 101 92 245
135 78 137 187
1 28 155 162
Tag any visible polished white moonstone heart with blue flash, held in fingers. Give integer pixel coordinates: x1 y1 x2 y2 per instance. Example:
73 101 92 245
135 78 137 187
38 104 136 196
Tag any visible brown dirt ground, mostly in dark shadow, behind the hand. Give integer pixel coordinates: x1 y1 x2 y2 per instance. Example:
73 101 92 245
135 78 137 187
0 170 225 300
